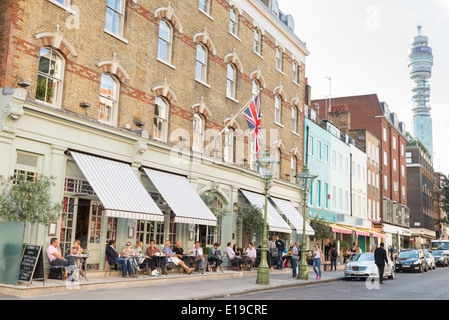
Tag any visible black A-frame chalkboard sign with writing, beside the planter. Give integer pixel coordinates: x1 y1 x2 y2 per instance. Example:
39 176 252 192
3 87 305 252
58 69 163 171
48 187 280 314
19 245 45 284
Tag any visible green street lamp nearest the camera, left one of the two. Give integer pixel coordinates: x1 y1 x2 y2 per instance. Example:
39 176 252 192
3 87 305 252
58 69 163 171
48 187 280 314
256 149 278 285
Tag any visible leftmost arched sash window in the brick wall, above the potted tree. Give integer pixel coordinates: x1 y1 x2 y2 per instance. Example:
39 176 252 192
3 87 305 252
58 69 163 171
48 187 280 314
36 48 64 106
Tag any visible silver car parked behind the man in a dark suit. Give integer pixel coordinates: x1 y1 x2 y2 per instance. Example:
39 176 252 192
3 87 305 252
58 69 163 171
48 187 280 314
345 252 395 279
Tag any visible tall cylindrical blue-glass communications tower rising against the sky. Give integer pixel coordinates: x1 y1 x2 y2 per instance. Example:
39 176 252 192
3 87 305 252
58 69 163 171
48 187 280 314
408 26 433 156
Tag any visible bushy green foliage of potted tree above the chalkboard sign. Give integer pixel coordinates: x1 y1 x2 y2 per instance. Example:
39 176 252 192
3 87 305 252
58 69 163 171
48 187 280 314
0 174 62 226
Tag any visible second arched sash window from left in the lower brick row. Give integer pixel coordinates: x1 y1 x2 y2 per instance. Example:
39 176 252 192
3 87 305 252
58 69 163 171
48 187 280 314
98 73 119 123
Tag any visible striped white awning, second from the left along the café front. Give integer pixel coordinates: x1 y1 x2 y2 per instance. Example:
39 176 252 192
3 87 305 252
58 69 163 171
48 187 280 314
144 168 217 226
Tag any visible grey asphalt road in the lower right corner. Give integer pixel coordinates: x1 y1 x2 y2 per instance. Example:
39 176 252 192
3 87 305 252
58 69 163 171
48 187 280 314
218 268 449 301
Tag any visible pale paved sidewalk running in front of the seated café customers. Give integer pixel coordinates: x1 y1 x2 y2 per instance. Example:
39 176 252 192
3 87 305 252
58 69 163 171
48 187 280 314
0 266 344 300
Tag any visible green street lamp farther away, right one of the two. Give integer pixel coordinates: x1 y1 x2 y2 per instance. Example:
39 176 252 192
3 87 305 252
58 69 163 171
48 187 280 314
296 165 317 280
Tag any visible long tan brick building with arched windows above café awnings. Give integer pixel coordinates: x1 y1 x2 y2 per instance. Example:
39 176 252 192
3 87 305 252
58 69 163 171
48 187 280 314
0 0 309 267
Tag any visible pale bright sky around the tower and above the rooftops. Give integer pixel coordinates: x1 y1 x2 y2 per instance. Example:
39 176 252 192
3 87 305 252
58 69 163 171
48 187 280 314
278 0 449 175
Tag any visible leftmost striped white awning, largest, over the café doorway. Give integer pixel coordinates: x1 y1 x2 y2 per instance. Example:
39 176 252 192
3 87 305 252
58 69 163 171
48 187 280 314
70 151 164 221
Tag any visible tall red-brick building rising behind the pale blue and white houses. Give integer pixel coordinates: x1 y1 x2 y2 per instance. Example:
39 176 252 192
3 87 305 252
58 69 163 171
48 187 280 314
312 94 410 252
